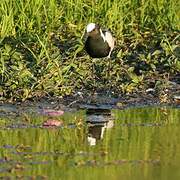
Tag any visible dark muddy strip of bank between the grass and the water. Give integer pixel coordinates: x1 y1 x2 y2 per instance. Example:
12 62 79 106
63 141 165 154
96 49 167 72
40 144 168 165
0 80 180 115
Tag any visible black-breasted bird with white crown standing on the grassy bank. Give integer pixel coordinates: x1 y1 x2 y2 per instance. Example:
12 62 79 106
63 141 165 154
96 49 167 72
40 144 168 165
85 23 115 58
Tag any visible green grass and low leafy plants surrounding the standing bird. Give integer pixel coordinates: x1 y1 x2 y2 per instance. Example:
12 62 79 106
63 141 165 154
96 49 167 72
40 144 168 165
0 0 180 100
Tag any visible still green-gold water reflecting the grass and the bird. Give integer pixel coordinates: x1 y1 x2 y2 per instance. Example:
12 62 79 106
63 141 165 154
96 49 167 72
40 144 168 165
0 107 180 180
